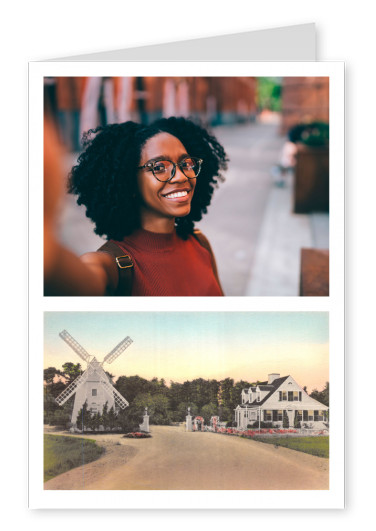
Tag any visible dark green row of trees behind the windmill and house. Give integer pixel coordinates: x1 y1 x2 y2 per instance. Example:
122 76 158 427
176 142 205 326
44 362 329 431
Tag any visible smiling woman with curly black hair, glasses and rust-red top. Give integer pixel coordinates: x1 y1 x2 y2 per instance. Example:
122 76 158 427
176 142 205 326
45 118 227 296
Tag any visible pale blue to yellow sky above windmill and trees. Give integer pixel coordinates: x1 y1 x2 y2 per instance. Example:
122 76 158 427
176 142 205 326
44 312 329 391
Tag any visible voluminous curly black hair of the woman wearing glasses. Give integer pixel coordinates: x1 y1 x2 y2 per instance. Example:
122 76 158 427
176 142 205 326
68 117 228 241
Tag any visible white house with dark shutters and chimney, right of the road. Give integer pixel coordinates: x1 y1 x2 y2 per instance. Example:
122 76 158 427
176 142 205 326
235 373 329 429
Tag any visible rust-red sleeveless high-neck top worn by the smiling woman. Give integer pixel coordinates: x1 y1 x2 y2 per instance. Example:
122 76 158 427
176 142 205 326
115 229 222 297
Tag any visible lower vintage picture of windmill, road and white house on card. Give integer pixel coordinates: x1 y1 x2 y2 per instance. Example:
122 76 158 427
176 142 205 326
43 312 330 490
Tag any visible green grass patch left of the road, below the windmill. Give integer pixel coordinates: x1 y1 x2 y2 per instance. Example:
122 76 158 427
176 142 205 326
44 434 104 481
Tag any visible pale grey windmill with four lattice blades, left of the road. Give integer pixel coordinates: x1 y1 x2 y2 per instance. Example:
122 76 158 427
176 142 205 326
56 330 133 425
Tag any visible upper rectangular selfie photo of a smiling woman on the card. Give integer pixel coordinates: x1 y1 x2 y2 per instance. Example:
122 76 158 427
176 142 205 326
43 76 329 297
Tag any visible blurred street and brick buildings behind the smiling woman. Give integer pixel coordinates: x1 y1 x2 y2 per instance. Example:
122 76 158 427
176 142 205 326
44 77 329 296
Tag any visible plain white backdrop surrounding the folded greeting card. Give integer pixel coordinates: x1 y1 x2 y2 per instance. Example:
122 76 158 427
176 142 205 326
0 0 376 530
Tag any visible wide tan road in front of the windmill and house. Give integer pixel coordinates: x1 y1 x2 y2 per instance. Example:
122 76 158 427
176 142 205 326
45 426 329 490
